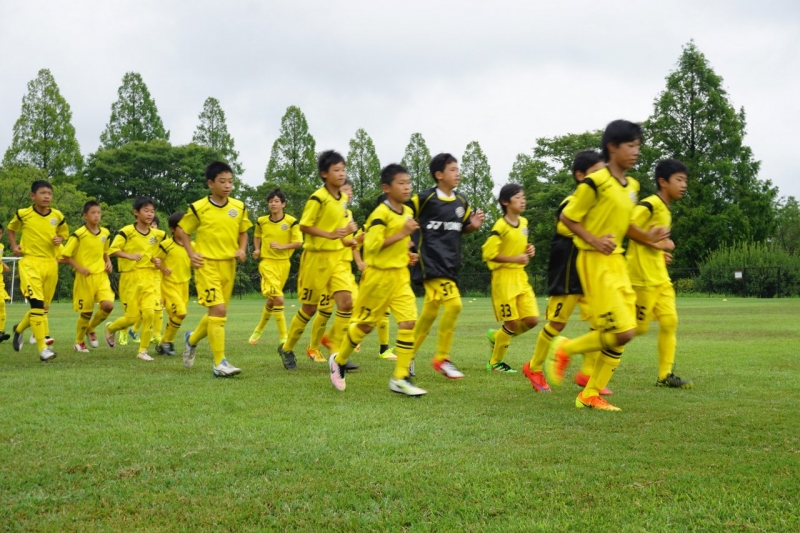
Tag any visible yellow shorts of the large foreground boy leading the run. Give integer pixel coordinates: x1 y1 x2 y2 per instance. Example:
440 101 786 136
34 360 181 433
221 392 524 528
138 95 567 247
577 250 636 333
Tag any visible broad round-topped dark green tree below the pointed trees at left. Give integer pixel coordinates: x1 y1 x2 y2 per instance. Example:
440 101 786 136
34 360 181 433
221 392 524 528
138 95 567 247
83 140 221 218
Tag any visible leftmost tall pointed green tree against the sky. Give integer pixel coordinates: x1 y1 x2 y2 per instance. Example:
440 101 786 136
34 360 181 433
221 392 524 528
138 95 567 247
3 69 83 181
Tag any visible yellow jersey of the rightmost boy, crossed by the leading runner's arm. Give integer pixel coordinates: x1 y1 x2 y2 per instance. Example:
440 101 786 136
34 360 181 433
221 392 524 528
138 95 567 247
625 194 672 287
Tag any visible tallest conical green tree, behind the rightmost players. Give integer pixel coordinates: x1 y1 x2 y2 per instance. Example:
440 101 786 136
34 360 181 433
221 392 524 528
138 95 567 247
641 42 777 267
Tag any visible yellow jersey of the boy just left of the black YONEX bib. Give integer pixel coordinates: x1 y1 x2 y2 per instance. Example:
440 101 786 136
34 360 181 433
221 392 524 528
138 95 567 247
364 202 414 270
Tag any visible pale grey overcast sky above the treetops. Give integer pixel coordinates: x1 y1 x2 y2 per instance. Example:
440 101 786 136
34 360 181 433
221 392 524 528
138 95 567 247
0 0 800 197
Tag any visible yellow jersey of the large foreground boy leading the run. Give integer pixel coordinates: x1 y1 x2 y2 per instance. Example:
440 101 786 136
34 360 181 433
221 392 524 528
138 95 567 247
562 168 639 254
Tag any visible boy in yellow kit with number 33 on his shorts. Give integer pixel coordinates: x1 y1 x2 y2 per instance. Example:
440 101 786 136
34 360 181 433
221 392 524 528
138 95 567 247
482 183 539 373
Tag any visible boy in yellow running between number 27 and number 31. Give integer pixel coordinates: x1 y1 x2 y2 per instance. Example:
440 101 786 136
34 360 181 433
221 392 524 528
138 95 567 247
250 189 303 344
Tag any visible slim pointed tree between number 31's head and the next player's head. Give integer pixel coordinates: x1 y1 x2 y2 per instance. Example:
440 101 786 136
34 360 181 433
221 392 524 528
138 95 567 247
347 128 381 224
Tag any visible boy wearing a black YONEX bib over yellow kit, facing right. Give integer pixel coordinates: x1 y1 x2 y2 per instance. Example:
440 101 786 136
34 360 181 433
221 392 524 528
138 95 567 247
411 154 484 379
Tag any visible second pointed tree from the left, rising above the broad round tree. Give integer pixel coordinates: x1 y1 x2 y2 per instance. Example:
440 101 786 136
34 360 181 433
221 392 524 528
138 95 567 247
100 72 169 150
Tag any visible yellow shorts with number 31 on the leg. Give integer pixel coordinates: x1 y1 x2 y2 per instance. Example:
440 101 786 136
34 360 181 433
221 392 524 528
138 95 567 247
297 250 353 306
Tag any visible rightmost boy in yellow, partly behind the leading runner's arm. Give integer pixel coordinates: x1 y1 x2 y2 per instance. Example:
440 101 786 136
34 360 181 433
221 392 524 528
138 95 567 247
626 159 692 389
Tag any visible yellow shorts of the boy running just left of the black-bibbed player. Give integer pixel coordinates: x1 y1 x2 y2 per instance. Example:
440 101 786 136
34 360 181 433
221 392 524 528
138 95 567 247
353 267 417 327
